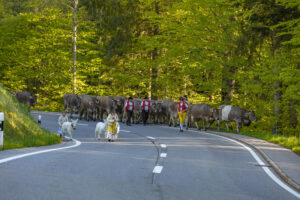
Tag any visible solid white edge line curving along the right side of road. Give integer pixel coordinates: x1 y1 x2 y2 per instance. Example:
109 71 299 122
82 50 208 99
188 130 300 199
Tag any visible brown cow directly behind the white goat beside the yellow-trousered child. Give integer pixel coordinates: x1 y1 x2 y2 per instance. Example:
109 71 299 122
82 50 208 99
96 96 117 121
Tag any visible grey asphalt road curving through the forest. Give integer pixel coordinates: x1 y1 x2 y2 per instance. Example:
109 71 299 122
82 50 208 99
0 114 297 200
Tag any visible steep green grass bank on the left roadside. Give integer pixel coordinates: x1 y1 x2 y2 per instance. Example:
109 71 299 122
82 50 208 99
0 85 61 149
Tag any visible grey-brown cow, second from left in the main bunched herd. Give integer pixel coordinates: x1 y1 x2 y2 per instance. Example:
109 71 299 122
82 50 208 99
79 95 99 121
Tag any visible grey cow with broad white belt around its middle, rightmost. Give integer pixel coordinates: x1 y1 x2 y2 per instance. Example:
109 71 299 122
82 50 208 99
218 105 256 133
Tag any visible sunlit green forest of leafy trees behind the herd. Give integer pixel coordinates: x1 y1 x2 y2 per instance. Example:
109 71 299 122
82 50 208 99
0 0 300 138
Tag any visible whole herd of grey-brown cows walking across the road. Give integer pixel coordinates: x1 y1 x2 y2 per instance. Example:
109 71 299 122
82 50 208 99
14 91 256 132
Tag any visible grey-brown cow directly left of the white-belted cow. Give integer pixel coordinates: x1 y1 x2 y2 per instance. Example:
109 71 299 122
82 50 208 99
186 103 218 131
